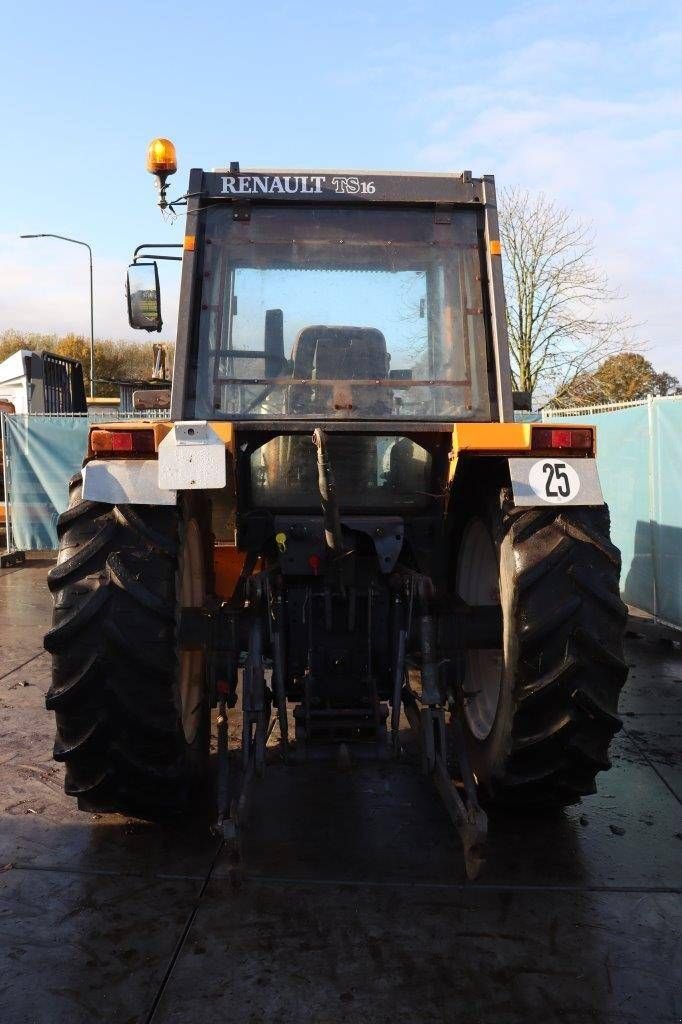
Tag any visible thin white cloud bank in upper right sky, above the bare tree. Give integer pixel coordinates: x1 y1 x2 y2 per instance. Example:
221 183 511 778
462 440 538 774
409 33 682 377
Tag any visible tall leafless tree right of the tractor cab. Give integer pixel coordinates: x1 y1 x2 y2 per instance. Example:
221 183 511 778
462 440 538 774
500 188 637 399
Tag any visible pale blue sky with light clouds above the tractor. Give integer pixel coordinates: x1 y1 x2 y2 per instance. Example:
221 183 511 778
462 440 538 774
0 0 682 376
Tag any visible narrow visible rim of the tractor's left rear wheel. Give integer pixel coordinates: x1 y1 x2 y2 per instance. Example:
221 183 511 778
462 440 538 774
180 519 206 743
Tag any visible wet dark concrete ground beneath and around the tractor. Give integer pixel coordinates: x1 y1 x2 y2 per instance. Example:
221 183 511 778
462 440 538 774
0 560 682 1024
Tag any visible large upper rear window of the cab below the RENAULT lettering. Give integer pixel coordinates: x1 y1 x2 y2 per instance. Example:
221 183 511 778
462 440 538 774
183 195 499 422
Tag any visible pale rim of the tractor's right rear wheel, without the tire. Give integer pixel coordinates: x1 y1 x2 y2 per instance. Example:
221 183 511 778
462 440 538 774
457 519 504 740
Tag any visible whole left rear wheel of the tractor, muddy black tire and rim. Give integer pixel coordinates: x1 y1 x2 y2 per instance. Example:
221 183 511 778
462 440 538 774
45 474 210 818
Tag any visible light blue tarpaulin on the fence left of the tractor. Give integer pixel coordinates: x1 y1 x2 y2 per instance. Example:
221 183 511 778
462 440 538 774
4 414 88 551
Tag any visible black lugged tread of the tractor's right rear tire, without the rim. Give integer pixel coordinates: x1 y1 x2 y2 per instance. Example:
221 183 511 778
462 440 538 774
477 488 627 808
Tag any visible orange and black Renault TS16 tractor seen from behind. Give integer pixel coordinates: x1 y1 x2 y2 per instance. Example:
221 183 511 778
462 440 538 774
45 139 627 878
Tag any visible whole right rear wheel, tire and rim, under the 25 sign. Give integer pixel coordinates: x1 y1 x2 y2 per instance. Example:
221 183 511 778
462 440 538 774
457 487 627 808
